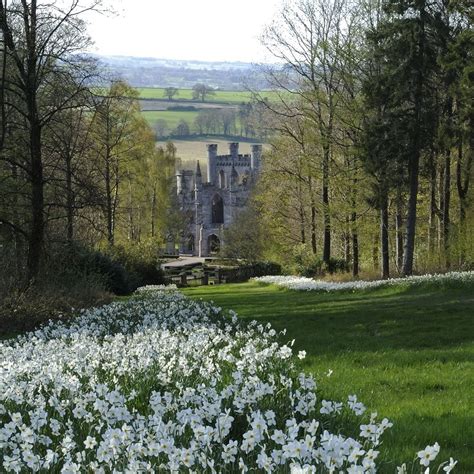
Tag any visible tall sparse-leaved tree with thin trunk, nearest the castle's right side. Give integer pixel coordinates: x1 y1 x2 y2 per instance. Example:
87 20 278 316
263 0 353 263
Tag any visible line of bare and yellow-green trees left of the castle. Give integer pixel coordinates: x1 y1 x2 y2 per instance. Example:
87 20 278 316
0 0 176 300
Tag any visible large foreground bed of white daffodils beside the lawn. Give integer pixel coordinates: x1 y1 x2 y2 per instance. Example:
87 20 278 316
0 288 455 473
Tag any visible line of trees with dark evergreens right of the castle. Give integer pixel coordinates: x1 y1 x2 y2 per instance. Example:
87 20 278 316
239 0 474 278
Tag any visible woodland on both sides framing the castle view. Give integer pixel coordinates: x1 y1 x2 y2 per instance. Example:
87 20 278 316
0 0 474 326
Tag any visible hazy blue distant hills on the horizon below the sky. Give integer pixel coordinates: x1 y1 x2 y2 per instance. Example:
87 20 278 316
94 55 268 90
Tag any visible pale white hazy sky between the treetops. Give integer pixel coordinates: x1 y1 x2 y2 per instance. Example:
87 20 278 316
89 0 281 62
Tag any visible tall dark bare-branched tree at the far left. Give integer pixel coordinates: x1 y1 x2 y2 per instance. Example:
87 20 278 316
0 0 100 280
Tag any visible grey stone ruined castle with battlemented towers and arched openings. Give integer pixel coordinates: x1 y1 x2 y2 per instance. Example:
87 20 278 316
176 143 262 257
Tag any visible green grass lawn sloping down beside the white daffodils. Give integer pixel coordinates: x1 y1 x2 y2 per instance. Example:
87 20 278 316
184 283 474 473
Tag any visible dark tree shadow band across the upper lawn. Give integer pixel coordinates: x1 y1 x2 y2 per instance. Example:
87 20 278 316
186 283 474 356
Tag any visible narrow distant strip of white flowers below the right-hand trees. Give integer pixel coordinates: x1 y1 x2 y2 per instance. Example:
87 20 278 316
254 271 474 292
